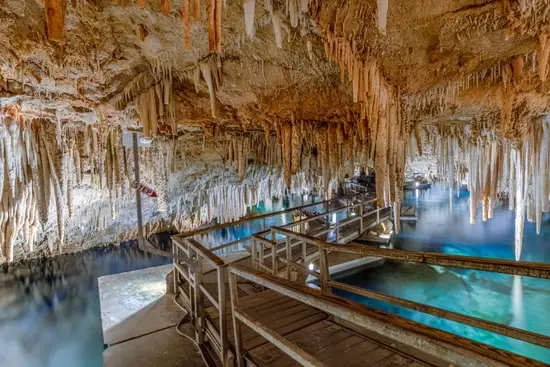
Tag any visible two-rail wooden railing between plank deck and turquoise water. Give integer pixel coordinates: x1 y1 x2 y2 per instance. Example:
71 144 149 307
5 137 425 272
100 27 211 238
271 227 550 348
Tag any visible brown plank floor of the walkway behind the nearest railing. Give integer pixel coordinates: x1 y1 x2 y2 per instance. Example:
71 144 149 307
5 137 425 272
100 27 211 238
230 291 431 367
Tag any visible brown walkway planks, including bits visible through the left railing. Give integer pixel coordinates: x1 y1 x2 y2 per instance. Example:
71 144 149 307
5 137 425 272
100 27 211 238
184 257 448 367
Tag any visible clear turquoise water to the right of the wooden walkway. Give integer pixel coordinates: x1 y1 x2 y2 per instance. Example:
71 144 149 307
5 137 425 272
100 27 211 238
332 186 550 363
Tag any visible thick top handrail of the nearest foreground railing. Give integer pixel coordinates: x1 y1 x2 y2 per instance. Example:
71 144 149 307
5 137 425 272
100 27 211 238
228 264 543 366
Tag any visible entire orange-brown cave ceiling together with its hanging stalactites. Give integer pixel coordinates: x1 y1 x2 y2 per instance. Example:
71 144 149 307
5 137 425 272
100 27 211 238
0 0 550 259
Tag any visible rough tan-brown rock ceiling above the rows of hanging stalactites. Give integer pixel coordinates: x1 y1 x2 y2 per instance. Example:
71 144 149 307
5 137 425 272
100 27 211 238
0 0 548 128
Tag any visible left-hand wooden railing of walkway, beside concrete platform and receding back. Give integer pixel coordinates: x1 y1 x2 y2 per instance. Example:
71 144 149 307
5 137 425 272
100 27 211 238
172 188 384 366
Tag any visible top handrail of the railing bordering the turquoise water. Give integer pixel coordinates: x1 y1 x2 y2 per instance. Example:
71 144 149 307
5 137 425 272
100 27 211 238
272 227 550 279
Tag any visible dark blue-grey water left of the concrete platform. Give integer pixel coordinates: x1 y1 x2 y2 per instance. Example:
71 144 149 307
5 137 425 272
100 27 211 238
0 241 170 367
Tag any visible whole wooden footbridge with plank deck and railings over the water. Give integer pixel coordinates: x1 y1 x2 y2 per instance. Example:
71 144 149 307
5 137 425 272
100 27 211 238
173 194 550 367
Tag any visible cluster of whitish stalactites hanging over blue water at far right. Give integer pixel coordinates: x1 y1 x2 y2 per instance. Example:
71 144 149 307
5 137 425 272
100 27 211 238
426 113 550 260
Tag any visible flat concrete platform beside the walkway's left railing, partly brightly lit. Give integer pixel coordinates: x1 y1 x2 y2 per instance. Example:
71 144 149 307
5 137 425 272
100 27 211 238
98 265 207 367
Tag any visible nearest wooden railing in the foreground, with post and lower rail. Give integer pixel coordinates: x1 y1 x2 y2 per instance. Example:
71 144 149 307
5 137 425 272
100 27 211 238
229 265 548 367
